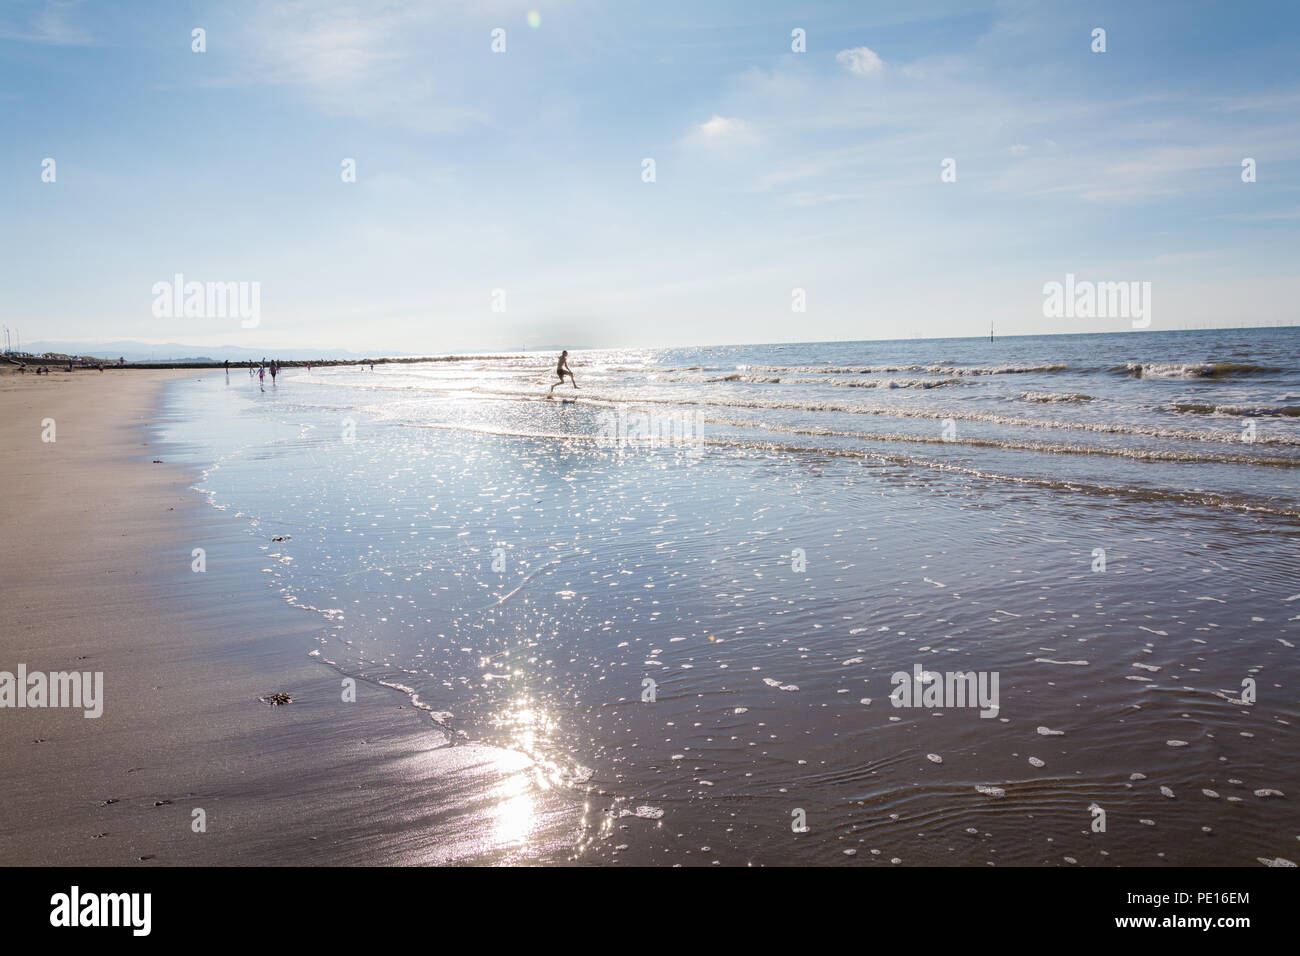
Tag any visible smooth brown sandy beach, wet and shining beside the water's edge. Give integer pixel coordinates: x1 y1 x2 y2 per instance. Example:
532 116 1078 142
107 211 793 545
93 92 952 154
0 369 580 865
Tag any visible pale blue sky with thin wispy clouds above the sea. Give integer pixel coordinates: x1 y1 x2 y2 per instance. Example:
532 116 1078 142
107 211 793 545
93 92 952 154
0 0 1300 354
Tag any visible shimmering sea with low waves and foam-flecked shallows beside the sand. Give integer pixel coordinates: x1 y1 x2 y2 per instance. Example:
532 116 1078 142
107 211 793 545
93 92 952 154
169 329 1300 866
